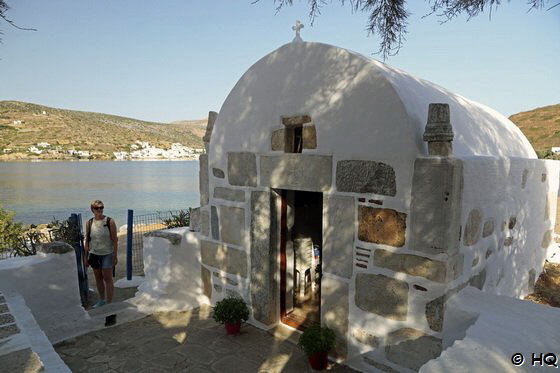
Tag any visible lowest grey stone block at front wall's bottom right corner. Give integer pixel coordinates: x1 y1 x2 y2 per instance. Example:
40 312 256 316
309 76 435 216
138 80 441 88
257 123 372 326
385 328 442 371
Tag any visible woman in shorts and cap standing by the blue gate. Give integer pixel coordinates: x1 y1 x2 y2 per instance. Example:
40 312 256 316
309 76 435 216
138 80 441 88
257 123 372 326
85 200 118 308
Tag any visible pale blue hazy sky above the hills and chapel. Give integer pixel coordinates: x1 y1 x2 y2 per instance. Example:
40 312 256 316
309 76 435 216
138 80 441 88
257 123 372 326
0 0 560 122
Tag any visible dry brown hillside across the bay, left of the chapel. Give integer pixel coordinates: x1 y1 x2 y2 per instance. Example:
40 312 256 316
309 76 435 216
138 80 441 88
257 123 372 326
0 101 206 160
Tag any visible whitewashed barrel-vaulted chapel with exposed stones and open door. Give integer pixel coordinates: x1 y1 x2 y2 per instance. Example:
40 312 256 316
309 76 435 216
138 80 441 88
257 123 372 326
193 30 559 372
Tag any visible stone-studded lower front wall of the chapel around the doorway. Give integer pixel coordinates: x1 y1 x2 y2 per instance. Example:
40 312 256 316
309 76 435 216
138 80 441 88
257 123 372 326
200 141 462 371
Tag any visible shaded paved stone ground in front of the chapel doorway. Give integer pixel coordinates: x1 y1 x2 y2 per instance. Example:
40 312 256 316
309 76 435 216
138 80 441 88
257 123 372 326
55 306 355 373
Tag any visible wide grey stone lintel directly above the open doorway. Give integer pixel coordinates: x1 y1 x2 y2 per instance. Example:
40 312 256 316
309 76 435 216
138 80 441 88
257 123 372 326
260 154 332 192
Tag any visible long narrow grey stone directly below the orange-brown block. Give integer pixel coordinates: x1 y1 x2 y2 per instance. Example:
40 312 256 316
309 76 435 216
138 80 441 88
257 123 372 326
373 249 447 283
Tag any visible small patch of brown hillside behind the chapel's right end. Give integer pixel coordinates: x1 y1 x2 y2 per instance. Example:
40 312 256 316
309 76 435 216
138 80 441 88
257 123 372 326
509 104 560 157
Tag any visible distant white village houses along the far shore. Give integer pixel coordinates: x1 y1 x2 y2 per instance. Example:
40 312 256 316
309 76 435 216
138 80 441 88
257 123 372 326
24 141 204 160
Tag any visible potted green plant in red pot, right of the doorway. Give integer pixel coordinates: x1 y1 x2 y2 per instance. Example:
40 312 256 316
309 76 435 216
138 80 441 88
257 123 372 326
298 324 336 370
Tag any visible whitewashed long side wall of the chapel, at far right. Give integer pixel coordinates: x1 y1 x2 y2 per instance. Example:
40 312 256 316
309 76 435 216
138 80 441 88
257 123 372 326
458 157 560 297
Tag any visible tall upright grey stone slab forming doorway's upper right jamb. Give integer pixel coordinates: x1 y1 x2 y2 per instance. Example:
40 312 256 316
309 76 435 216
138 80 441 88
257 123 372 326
322 195 355 278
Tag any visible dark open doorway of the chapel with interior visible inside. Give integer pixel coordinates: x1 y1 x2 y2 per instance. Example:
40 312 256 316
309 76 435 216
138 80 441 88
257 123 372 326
280 190 323 329
